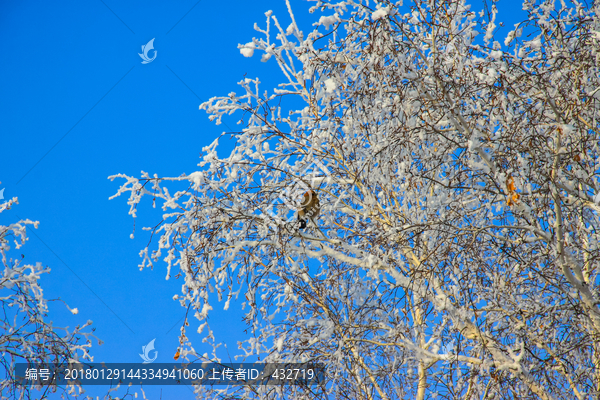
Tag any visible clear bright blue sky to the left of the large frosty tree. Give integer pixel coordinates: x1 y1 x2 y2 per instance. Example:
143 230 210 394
0 0 520 399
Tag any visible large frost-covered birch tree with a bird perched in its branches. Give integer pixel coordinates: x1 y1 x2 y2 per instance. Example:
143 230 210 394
111 0 600 400
